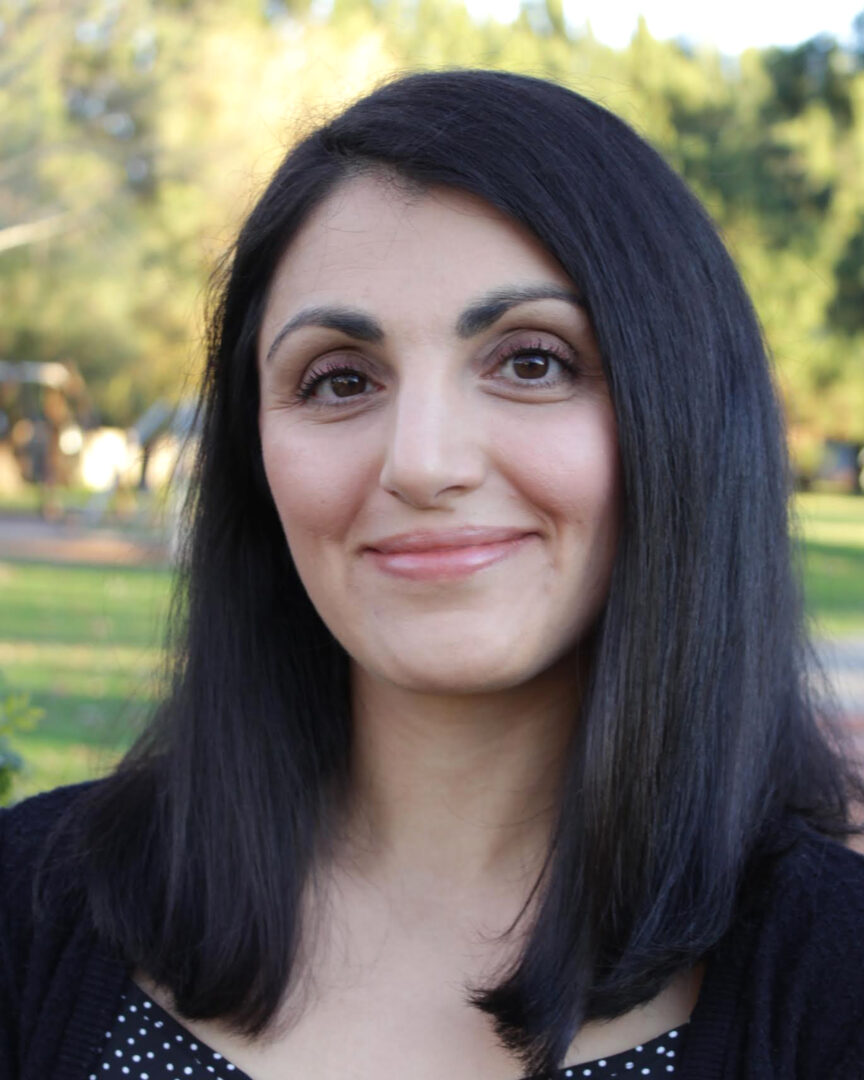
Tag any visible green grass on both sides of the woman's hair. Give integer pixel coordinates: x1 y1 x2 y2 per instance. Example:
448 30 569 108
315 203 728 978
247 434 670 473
0 495 864 797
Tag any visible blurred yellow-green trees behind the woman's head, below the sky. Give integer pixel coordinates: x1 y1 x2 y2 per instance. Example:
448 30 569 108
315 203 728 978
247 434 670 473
0 0 864 443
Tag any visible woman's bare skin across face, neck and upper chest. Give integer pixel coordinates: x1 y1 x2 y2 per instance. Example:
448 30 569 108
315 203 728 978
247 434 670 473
136 176 699 1080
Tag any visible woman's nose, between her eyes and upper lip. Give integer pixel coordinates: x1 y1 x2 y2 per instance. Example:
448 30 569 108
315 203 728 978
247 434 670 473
380 371 486 509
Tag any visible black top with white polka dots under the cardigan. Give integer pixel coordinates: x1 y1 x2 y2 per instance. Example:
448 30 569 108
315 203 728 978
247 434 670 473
89 981 687 1080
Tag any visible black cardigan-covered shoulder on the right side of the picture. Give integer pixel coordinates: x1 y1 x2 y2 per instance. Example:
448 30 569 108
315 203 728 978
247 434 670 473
693 821 864 1080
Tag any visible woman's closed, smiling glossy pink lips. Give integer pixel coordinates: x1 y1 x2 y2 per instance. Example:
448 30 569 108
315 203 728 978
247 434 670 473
366 527 537 581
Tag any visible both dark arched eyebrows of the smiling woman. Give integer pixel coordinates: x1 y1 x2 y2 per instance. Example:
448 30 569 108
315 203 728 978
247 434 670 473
265 284 583 363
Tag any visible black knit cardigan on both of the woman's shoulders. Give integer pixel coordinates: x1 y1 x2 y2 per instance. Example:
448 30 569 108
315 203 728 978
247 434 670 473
0 786 864 1080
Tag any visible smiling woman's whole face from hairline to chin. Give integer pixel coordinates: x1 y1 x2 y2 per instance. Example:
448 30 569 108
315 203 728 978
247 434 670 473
259 176 619 693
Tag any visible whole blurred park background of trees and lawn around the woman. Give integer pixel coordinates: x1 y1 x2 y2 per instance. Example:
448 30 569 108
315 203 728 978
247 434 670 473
0 0 864 800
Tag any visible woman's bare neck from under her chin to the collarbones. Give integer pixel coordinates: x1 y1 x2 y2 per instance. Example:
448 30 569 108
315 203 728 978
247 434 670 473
336 656 579 897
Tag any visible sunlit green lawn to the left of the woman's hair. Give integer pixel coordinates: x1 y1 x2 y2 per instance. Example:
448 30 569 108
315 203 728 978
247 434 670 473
0 562 171 798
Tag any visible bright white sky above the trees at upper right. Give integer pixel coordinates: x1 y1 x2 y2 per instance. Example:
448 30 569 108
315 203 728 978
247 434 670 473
467 0 864 54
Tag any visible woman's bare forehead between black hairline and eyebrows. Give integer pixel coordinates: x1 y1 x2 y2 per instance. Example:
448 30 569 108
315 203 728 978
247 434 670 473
261 176 571 342
